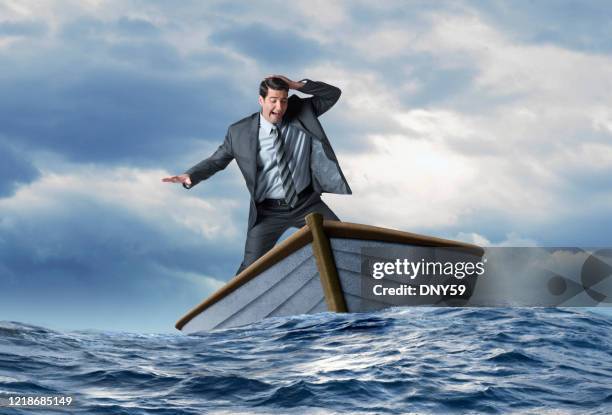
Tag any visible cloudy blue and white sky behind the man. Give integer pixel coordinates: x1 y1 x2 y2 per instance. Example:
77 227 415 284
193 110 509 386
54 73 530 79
0 0 612 332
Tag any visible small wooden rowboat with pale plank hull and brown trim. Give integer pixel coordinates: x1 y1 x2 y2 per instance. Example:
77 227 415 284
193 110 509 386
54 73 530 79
175 214 484 334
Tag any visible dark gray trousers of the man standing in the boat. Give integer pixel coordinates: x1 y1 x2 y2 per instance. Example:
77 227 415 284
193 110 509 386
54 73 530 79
236 192 340 275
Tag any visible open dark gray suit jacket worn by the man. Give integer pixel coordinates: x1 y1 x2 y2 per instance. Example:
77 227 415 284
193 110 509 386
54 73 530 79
185 79 351 229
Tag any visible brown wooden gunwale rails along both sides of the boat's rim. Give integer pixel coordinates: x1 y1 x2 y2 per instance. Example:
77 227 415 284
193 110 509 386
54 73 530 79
175 220 484 330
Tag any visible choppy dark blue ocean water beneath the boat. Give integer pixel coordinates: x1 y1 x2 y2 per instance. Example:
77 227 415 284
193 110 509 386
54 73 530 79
0 308 612 415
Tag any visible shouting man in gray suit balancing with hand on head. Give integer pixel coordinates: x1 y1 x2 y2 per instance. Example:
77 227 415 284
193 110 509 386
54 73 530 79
162 75 351 274
